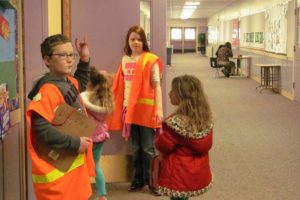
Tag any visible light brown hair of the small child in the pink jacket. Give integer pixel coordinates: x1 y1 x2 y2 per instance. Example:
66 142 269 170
89 66 114 113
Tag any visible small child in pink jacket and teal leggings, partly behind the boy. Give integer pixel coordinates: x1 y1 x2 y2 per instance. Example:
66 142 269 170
81 67 113 200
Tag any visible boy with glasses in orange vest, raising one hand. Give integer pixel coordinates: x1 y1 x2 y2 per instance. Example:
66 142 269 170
26 34 95 200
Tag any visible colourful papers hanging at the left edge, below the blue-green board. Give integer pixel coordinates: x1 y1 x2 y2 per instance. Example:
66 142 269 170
0 83 10 140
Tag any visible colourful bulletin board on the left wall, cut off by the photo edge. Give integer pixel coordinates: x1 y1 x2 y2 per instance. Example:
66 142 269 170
0 0 19 139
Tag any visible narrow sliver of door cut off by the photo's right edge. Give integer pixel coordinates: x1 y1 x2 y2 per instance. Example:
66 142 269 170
294 0 300 102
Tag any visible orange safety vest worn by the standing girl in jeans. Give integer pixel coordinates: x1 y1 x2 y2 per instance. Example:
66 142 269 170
108 52 162 130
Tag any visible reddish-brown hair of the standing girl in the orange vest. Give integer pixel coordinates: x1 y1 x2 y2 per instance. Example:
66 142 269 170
124 26 150 56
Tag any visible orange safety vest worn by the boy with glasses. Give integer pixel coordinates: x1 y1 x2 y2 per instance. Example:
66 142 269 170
26 77 95 200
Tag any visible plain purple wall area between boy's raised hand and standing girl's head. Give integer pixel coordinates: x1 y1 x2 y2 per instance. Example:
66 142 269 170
71 0 140 72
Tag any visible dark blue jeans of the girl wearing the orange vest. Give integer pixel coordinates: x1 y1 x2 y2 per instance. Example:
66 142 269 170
130 124 155 185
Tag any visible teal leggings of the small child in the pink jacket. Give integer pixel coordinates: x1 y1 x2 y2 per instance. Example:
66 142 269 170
93 142 106 196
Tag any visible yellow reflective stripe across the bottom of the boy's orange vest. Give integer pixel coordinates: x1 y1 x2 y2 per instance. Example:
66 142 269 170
32 154 84 183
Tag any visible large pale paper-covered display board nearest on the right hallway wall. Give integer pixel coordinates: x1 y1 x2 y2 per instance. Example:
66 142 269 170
265 4 288 54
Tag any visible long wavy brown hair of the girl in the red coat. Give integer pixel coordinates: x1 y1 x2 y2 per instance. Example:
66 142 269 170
172 75 212 131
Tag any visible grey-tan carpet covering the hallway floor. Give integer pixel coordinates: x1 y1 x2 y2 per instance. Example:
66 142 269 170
90 54 300 200
